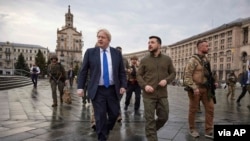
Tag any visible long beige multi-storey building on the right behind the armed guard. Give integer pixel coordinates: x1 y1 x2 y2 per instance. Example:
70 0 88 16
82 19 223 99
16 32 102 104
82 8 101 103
125 17 250 82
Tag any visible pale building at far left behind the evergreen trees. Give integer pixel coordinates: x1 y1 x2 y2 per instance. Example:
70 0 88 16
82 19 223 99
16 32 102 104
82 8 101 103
0 42 49 75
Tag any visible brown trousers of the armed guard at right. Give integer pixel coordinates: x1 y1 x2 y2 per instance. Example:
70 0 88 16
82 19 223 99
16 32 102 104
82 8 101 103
188 88 214 134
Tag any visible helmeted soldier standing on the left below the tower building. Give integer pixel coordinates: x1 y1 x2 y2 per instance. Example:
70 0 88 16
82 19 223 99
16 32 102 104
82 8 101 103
48 55 66 107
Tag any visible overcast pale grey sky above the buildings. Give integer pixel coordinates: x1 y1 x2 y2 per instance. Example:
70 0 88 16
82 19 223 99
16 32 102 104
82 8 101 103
0 0 250 54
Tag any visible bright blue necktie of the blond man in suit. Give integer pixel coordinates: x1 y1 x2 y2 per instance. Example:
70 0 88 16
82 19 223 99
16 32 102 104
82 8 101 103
103 49 109 88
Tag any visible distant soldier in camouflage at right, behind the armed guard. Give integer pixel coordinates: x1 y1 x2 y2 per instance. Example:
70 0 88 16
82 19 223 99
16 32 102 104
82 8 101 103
226 71 237 100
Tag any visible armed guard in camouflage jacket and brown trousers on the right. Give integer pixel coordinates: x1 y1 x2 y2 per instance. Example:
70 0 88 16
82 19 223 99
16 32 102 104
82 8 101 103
183 40 218 138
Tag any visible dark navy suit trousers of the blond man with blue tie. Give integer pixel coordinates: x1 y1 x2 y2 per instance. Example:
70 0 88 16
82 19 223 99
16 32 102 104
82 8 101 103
92 85 120 141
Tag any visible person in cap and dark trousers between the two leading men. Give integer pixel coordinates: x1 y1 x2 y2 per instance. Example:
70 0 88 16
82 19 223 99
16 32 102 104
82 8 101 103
124 56 141 112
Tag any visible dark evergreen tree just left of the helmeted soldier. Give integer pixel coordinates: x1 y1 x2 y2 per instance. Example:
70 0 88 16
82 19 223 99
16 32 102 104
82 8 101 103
35 49 47 76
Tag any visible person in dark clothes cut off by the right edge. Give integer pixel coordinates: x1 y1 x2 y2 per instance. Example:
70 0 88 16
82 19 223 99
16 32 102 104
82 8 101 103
236 64 250 106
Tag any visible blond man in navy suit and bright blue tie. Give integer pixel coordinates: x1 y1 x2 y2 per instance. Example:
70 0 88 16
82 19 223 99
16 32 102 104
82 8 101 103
77 29 127 141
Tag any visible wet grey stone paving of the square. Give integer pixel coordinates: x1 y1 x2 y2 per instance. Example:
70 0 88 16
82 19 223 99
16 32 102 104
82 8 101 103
0 79 250 141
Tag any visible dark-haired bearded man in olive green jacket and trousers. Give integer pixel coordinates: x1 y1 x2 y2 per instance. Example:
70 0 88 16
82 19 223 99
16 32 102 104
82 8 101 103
137 36 176 141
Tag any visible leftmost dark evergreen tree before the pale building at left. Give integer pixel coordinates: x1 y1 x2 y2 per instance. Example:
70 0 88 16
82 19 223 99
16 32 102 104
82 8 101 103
15 53 30 76
